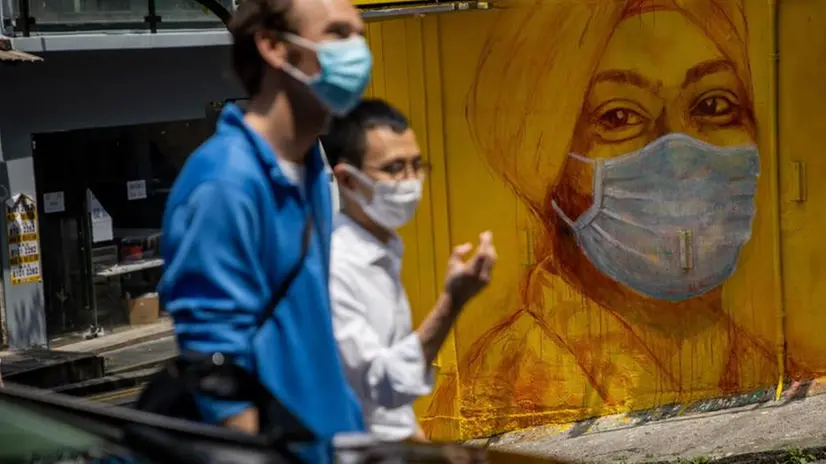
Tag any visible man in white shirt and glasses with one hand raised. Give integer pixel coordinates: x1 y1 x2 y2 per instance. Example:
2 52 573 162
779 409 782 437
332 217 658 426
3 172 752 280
322 100 496 441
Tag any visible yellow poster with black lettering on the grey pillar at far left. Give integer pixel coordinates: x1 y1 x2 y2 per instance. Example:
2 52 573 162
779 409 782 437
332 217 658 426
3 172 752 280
6 193 41 285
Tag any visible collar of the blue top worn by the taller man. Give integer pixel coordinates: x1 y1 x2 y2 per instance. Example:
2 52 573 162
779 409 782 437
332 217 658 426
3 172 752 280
216 103 325 185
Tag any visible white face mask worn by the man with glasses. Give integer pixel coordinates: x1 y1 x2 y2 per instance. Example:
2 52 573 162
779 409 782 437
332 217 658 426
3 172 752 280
339 165 422 230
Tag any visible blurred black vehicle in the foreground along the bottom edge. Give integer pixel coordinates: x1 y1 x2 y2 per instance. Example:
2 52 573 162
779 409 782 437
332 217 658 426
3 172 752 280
0 384 563 464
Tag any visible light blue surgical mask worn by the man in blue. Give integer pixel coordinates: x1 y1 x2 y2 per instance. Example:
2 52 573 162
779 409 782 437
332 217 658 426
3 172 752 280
283 33 373 115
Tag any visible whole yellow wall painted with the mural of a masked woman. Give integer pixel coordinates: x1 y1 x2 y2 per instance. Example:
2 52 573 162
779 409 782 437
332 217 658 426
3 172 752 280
360 0 826 439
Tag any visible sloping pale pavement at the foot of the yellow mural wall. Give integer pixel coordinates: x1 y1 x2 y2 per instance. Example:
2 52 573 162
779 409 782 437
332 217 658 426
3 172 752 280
475 382 826 463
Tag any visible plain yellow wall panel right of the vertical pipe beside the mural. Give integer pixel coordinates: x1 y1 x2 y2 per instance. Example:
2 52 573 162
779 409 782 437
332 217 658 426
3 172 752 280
779 1 826 377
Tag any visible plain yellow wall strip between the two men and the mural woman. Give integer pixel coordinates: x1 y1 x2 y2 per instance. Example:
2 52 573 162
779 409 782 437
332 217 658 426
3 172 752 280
366 18 456 424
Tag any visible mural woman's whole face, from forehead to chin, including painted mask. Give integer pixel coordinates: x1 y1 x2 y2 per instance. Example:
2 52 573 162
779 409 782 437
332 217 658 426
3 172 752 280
554 12 759 301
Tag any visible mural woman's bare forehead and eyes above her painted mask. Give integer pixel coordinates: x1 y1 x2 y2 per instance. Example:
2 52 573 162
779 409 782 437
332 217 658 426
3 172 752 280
572 11 754 159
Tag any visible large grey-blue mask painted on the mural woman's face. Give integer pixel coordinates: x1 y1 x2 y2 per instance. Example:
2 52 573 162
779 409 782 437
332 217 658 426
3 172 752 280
553 134 760 301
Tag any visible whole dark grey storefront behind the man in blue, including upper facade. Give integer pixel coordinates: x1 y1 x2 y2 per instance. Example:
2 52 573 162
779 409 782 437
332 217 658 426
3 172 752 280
0 46 242 349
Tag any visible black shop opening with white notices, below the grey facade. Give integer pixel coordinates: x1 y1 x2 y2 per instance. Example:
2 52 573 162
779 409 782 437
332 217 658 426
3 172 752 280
33 118 210 340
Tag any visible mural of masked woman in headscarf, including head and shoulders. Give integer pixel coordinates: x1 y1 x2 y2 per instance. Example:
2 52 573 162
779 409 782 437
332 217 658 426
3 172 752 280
424 0 796 438
